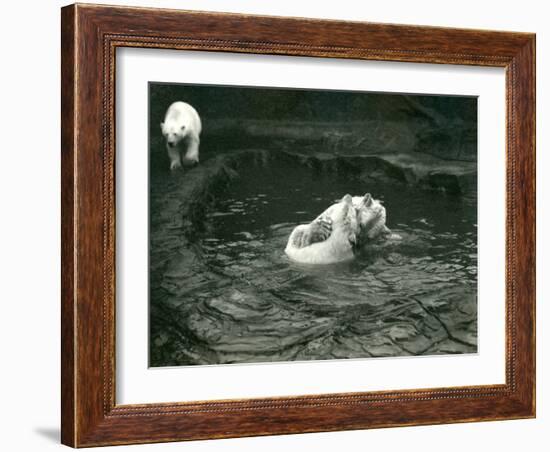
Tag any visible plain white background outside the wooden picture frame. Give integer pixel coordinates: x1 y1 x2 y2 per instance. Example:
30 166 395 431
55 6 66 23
0 0 550 452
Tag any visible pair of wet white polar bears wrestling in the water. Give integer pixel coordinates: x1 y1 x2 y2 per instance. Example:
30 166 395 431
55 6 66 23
285 193 391 264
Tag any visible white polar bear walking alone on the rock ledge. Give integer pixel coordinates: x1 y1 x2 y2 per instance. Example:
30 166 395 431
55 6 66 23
160 102 202 170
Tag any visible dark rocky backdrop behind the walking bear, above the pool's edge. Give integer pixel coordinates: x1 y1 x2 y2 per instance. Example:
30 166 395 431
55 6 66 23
149 82 477 167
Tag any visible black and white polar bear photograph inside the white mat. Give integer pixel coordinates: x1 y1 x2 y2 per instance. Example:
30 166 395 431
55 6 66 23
148 82 478 367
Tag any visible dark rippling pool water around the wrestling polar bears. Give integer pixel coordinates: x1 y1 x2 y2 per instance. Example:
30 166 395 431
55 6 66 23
150 154 477 366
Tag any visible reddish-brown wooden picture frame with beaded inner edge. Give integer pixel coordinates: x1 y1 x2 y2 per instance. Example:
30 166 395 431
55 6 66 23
61 4 535 447
